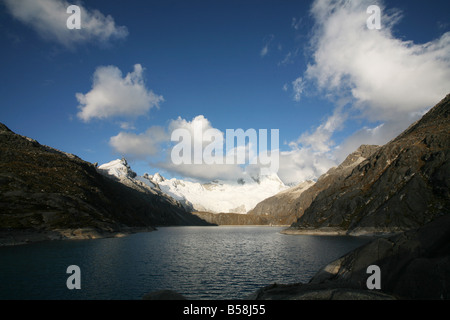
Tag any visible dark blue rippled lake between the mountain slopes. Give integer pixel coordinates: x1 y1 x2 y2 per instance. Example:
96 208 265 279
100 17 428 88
0 227 370 300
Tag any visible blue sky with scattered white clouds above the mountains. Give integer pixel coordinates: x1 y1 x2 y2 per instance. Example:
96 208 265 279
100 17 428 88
0 0 450 183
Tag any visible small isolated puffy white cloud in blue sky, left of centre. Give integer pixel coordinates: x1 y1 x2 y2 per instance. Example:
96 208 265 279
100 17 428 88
76 64 164 122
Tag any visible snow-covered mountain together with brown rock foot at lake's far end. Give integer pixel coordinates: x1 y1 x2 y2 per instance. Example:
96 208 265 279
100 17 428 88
98 159 290 225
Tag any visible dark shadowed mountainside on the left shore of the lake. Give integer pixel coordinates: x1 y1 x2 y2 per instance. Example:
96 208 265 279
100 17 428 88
0 124 209 245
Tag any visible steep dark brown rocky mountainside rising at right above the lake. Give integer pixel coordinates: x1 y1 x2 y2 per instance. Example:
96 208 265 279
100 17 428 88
291 95 450 234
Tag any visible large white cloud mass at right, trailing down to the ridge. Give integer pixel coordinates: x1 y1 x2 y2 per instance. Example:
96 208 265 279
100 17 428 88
279 0 450 181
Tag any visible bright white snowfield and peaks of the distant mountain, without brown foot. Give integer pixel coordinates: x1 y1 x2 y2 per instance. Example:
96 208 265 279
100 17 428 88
99 159 288 214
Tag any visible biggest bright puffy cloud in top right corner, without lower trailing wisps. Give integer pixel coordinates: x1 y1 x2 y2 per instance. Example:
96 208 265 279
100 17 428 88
303 0 450 121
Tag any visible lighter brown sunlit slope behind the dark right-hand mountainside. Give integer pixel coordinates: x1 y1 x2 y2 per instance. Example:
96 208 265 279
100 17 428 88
249 145 379 225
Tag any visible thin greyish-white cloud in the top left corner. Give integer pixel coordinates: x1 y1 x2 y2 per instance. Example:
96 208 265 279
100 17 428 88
4 0 128 47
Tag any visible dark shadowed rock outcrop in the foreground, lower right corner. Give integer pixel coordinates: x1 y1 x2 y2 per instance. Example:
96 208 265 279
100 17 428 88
249 215 450 300
